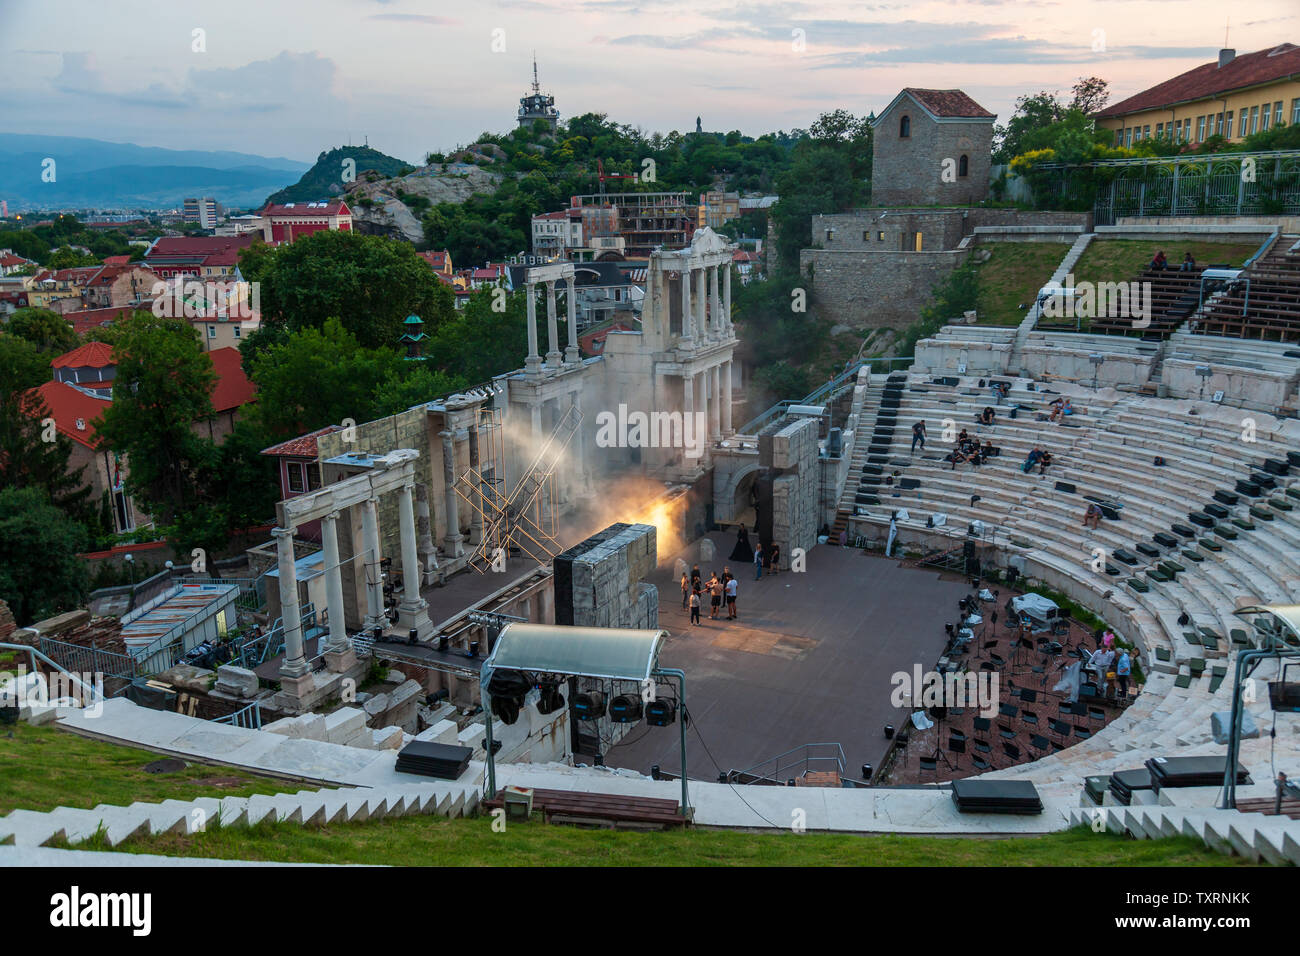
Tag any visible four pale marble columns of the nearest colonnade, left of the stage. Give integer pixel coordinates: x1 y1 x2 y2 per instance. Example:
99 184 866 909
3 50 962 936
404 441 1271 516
272 480 428 680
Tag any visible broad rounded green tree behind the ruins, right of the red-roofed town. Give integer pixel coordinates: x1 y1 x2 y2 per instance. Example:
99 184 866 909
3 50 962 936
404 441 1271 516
261 230 455 349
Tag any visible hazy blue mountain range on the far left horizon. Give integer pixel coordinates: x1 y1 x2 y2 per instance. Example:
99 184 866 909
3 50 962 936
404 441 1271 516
0 133 308 212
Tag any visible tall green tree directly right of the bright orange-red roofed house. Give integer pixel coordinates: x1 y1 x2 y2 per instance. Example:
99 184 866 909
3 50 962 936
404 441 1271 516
95 312 216 524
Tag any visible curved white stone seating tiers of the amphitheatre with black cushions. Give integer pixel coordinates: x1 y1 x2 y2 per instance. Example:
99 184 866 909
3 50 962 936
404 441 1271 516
840 376 1300 791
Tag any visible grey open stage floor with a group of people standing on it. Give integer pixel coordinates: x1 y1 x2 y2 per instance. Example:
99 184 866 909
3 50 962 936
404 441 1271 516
606 532 970 780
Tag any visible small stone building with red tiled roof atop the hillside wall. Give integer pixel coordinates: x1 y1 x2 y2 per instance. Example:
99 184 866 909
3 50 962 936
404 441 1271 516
871 87 997 206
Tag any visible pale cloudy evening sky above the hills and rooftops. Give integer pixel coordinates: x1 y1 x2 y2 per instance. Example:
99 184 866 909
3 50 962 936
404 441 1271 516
0 0 1300 161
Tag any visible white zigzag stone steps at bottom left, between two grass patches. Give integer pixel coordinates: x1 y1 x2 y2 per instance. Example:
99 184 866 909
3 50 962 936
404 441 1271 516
0 783 478 847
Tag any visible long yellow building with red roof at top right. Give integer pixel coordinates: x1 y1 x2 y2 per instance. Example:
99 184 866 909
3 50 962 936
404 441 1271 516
1093 43 1300 146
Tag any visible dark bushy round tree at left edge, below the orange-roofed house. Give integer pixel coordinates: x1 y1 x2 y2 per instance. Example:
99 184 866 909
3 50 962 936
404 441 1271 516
0 488 90 626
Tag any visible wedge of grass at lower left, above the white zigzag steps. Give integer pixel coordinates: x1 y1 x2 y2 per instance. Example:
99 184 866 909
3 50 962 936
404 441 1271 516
0 723 302 813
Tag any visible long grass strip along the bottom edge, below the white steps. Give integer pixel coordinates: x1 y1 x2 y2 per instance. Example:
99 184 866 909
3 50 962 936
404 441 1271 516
55 817 1245 866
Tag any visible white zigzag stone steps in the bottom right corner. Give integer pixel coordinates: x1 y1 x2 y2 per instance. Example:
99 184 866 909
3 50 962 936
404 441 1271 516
1069 805 1300 865
